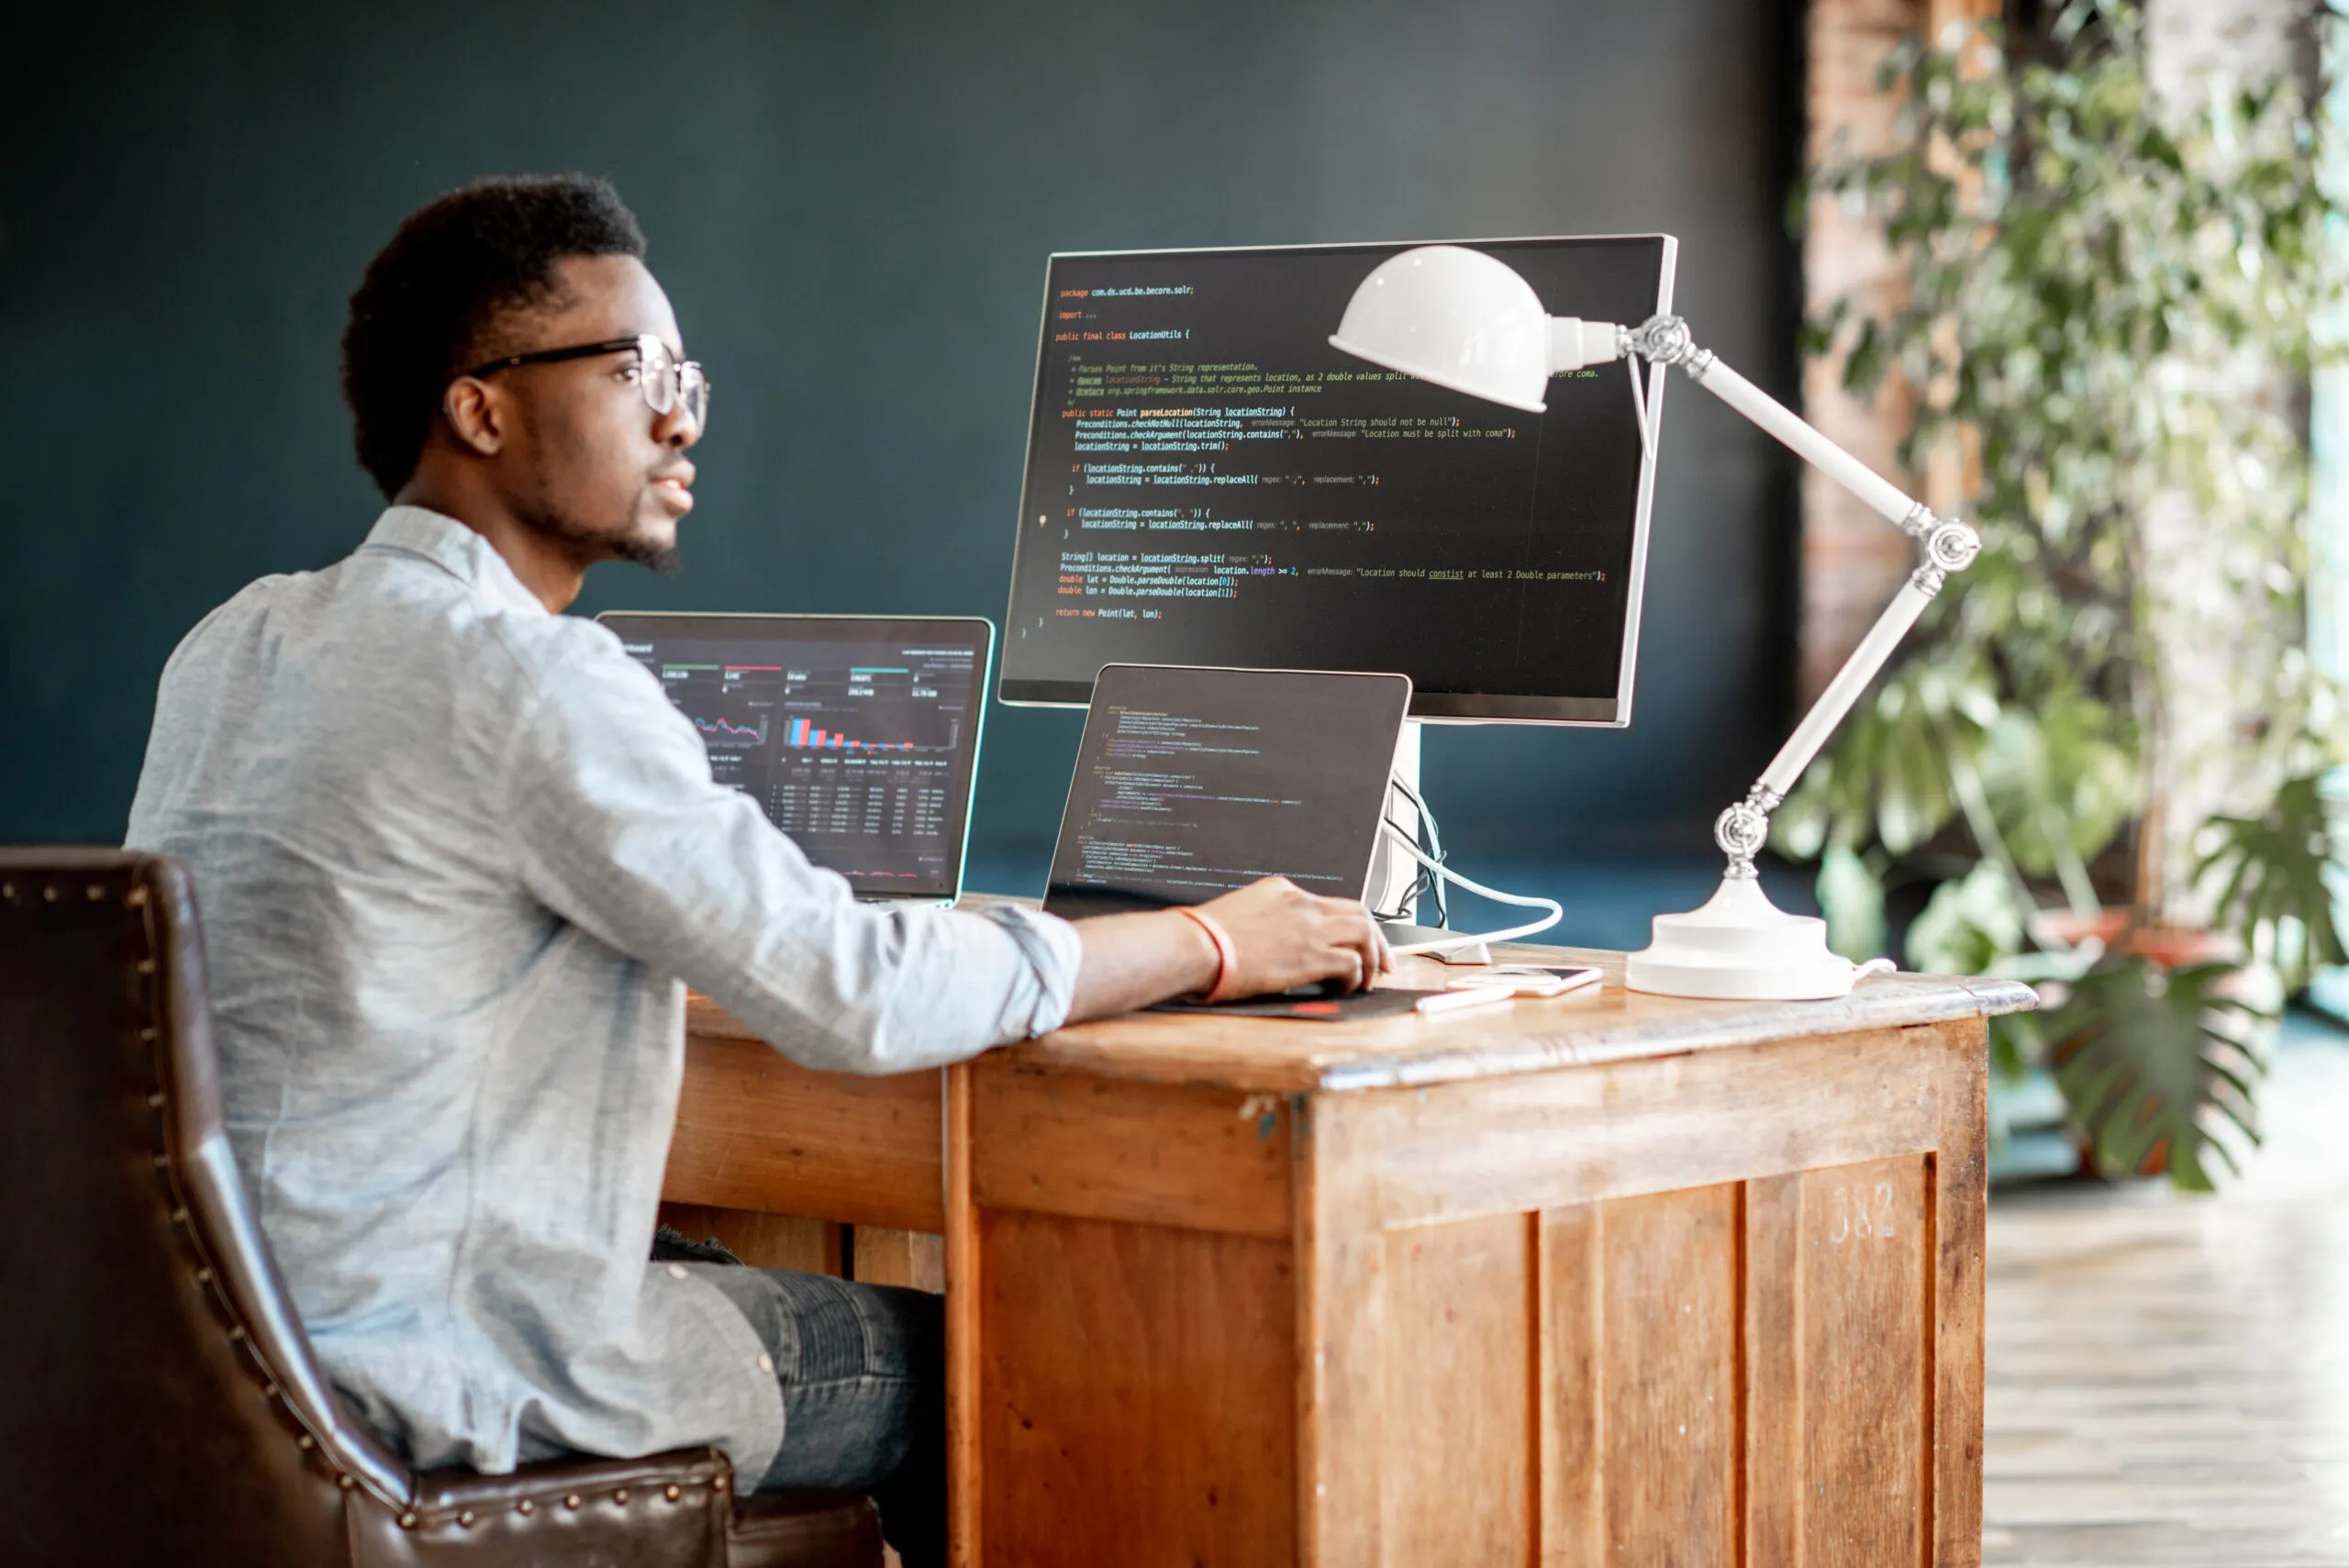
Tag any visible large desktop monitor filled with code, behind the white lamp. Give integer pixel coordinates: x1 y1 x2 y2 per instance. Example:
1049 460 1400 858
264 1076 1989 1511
998 235 1677 726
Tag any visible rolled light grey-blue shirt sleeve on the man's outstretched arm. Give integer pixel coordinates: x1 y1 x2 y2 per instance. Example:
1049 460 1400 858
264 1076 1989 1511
507 622 1081 1073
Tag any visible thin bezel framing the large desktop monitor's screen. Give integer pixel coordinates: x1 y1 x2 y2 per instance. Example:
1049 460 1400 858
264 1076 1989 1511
996 232 1679 730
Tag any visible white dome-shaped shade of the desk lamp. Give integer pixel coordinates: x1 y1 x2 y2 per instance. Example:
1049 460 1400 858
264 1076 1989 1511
1330 244 1551 413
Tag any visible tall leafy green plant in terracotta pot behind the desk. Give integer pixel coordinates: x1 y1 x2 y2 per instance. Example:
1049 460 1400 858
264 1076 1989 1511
1774 0 2342 1188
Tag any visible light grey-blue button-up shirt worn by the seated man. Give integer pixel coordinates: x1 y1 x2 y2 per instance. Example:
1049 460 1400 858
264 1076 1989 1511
127 507 1078 1485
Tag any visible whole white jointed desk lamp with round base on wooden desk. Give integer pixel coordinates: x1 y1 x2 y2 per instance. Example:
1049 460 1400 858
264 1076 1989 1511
1330 244 1983 1000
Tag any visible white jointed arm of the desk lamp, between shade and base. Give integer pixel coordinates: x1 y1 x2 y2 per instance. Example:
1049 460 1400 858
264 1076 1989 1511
1597 317 1983 880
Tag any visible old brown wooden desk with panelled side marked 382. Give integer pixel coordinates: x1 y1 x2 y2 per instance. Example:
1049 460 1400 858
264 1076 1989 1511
667 949 2034 1568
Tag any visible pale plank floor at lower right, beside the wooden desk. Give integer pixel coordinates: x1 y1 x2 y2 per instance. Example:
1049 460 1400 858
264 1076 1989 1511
1983 1018 2349 1568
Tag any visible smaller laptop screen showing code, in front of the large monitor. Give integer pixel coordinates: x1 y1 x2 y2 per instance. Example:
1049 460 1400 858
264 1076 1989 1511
1043 664 1412 920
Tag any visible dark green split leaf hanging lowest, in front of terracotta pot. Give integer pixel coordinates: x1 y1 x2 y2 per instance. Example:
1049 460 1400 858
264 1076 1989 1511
2046 958 2262 1193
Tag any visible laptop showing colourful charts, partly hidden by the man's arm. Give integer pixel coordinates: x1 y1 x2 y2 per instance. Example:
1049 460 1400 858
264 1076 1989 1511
596 610 996 904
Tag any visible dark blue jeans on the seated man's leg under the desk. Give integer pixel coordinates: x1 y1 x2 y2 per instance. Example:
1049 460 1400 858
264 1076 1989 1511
686 1262 947 1568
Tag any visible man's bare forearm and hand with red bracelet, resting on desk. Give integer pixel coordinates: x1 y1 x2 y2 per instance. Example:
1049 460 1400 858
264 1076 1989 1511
1069 875 1396 1023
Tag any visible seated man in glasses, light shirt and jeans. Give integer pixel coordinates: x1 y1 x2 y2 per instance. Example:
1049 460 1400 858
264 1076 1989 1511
129 176 1388 1561
